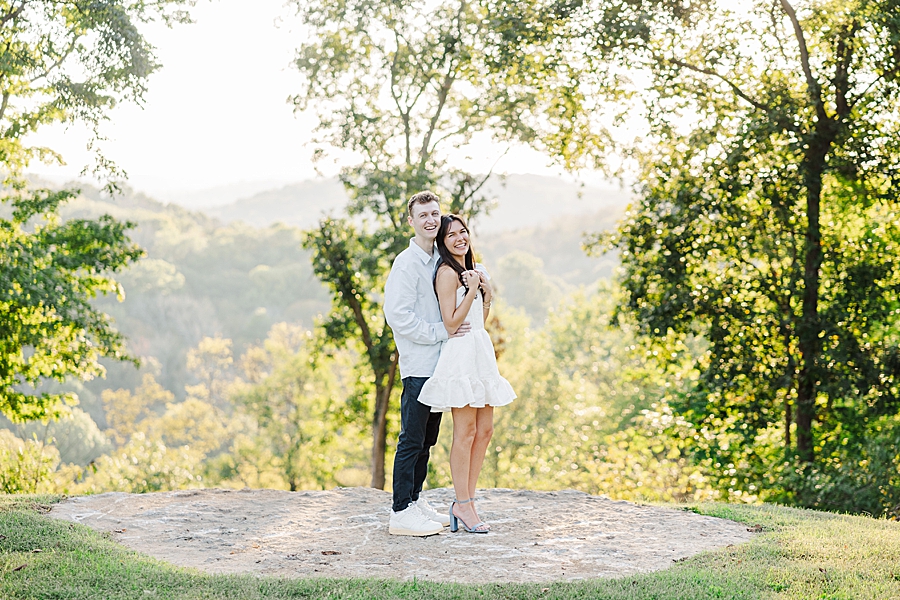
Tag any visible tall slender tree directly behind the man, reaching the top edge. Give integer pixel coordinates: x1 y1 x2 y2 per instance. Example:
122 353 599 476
293 0 588 488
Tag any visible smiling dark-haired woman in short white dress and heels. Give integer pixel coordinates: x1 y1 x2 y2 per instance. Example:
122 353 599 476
419 215 516 533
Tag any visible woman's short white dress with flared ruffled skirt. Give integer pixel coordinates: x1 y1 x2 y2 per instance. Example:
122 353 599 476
419 287 516 412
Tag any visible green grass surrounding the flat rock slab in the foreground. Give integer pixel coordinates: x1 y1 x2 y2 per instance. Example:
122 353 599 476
0 495 900 600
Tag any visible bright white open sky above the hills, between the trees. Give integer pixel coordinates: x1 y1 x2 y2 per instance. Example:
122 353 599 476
31 0 580 201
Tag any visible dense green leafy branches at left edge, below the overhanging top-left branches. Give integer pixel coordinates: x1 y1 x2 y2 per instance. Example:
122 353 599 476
0 191 142 422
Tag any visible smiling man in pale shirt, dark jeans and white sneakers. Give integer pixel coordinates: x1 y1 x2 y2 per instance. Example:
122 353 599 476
384 192 472 536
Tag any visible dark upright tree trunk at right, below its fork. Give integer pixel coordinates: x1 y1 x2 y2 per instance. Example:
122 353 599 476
795 142 831 463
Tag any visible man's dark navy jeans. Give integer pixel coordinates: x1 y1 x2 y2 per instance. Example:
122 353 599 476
393 377 442 512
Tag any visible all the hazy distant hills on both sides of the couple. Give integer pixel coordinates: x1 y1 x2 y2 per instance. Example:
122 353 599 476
14 175 628 410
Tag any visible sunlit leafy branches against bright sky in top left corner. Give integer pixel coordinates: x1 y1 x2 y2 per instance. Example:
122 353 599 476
0 0 192 182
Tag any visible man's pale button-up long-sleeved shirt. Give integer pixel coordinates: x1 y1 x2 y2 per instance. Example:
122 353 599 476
384 239 448 379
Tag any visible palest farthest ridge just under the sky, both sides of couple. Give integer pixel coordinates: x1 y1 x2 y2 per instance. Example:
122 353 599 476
201 175 630 233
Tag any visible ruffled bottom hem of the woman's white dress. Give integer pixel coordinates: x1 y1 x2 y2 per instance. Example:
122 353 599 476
419 375 516 412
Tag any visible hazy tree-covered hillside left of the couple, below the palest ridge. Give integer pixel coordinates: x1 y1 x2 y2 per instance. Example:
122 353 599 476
63 187 328 396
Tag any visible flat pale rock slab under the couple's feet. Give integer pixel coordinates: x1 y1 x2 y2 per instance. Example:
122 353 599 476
50 488 752 583
